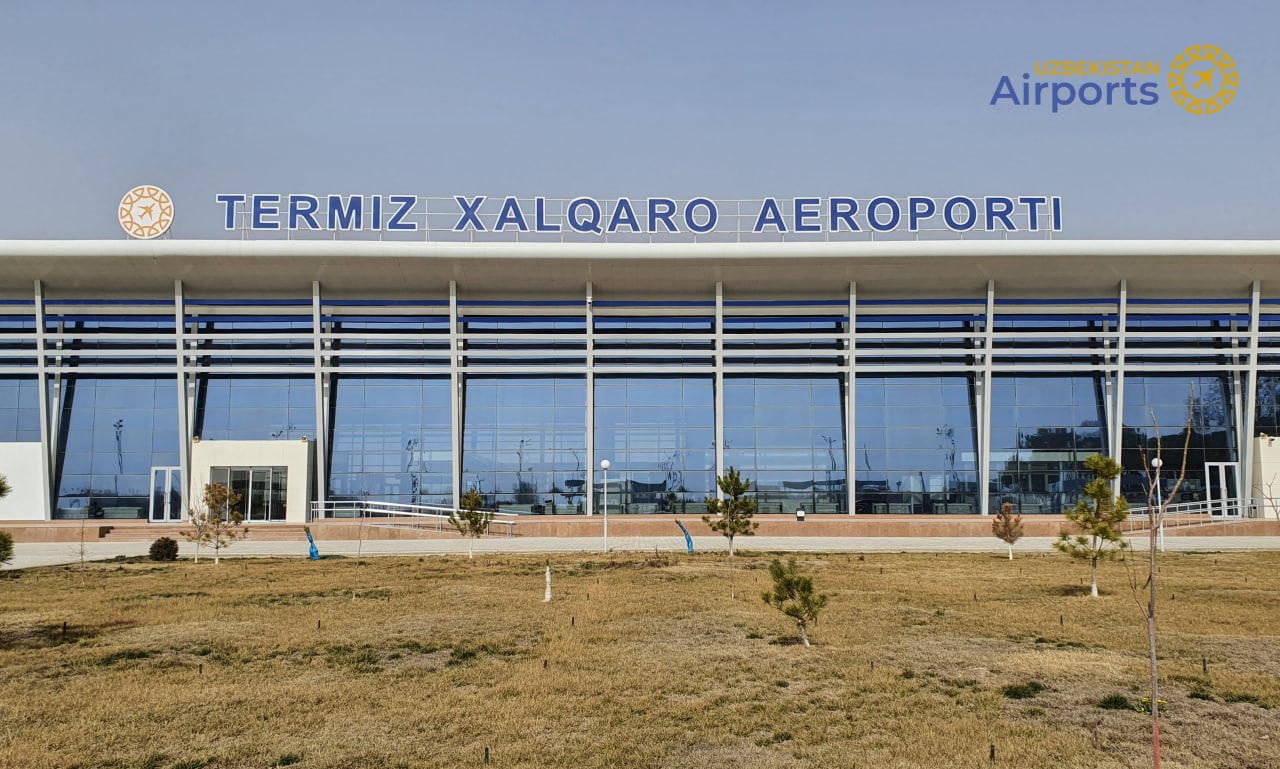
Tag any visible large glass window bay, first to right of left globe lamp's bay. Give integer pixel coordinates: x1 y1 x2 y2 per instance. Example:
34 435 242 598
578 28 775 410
724 375 847 513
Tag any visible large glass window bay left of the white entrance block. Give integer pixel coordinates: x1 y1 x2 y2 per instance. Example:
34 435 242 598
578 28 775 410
54 376 178 518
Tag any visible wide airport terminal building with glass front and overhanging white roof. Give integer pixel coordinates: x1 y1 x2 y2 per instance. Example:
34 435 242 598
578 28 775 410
0 196 1280 522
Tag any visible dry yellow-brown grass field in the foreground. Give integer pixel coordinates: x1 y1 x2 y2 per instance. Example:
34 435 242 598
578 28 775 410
0 543 1280 769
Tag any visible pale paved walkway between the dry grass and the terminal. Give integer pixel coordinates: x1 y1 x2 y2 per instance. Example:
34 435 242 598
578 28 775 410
6 536 1280 568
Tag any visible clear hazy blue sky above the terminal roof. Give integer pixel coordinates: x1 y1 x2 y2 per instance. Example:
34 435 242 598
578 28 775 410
0 0 1280 239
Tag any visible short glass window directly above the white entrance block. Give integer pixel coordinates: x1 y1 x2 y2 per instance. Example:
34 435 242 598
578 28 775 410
195 376 316 440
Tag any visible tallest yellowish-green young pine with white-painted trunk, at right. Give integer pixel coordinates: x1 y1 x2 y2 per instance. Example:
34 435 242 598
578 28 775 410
1053 454 1129 598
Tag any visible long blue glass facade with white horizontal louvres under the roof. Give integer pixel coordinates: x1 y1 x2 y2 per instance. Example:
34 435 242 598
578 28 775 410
0 278 1280 521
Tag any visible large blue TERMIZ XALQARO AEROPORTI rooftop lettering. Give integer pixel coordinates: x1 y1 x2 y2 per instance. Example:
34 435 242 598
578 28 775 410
215 193 1062 239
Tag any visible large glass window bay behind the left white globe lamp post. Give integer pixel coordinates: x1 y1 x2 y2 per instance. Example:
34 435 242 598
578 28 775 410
595 376 716 513
